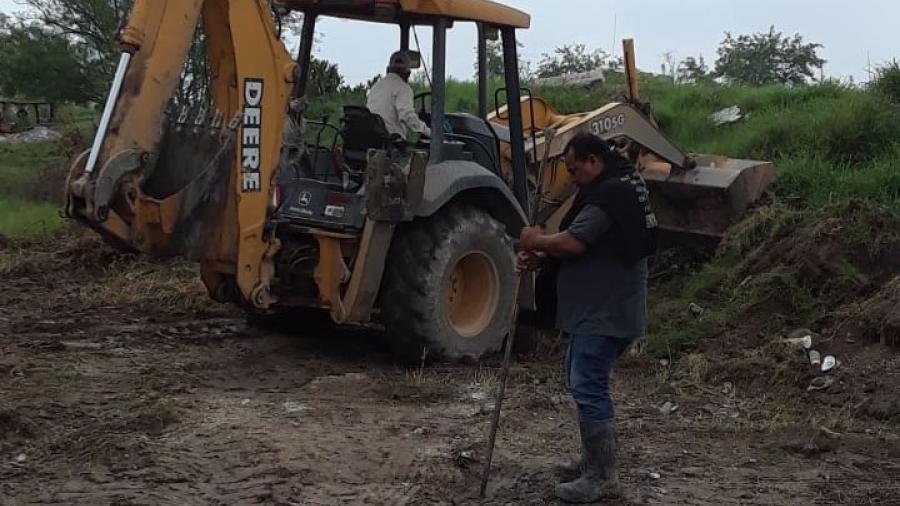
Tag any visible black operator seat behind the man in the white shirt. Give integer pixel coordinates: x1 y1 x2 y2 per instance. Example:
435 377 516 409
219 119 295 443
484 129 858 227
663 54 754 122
341 105 402 171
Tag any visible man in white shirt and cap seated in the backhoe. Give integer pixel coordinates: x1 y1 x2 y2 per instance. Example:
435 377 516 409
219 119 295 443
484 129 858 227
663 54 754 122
366 51 431 139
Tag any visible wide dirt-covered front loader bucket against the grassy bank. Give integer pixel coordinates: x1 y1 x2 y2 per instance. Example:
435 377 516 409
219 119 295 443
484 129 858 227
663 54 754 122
642 155 775 239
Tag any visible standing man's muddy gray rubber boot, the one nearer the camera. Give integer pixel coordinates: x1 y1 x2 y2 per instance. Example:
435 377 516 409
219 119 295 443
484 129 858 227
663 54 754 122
556 420 619 504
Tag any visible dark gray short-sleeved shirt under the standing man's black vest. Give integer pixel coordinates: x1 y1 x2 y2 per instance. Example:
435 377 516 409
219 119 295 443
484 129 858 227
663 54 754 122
557 205 647 339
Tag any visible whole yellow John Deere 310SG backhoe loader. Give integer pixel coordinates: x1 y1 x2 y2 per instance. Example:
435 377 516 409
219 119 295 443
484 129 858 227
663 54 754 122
66 0 771 359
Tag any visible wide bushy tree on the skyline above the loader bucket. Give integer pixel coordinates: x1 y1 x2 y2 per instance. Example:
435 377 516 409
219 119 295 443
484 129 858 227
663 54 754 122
714 26 825 86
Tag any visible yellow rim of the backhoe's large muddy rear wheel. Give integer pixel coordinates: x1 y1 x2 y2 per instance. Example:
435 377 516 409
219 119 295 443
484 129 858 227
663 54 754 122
446 251 500 337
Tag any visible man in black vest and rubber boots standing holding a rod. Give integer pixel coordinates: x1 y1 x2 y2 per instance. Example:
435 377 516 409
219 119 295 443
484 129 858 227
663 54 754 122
519 133 657 503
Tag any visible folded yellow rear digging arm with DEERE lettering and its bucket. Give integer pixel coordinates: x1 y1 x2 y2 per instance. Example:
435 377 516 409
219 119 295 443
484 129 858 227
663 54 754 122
66 0 295 307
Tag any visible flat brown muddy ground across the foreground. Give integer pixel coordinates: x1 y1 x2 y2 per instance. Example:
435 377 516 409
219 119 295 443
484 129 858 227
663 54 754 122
0 239 900 505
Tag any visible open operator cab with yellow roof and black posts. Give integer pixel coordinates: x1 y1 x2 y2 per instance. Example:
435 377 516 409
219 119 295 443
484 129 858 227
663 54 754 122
274 0 528 232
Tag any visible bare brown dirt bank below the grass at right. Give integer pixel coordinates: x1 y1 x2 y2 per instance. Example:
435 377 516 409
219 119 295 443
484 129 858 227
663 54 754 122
670 203 900 423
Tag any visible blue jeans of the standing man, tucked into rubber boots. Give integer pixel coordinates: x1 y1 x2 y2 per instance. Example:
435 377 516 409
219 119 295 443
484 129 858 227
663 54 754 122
566 334 634 422
